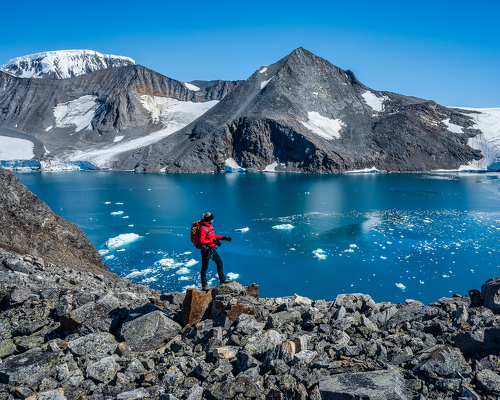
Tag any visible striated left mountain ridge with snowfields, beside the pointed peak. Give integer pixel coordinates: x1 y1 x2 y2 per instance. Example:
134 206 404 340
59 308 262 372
0 65 243 167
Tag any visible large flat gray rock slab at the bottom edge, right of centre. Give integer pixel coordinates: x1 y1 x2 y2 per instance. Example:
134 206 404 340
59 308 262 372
319 370 411 400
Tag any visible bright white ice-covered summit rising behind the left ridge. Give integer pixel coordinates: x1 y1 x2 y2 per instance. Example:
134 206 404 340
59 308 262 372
0 50 135 79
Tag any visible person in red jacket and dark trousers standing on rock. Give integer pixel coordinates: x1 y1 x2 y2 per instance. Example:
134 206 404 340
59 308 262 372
199 213 231 290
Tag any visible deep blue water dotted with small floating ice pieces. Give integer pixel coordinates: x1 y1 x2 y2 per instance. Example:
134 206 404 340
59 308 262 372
12 172 500 303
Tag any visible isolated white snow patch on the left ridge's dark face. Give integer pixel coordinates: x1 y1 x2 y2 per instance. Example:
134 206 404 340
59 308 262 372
54 95 99 132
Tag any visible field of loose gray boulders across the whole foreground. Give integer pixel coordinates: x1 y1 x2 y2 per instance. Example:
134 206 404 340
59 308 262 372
0 245 500 400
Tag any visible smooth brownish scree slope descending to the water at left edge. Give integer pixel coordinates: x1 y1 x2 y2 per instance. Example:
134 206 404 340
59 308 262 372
0 168 109 274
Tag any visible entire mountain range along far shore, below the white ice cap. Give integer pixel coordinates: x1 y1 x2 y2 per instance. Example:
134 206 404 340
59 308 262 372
0 48 500 173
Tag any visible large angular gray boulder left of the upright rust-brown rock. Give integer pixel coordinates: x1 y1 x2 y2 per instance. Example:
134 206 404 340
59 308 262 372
121 304 182 351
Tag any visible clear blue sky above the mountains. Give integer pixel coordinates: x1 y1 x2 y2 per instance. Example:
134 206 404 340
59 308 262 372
0 0 500 107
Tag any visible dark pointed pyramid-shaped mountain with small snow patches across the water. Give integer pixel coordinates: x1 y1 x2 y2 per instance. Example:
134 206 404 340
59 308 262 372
115 48 496 173
